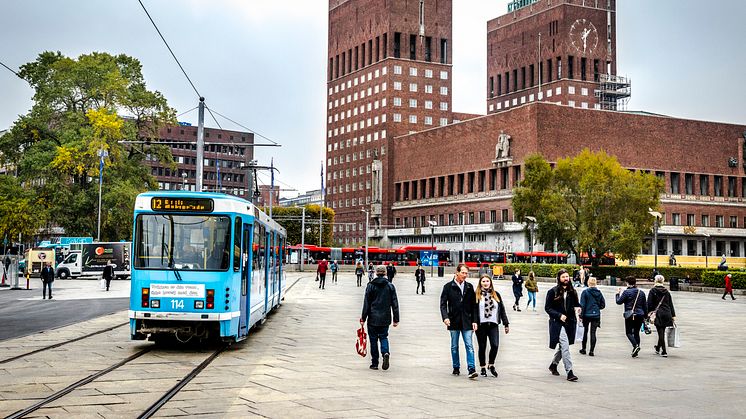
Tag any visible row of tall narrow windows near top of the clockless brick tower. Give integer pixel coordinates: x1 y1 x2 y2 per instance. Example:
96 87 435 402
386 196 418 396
328 32 448 81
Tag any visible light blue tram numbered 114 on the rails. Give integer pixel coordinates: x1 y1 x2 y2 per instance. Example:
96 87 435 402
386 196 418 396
129 191 286 342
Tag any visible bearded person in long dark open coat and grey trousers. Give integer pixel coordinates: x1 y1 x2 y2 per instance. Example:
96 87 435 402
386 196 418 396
544 269 580 381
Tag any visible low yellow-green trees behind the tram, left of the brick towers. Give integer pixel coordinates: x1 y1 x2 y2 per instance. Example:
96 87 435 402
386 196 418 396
264 205 334 246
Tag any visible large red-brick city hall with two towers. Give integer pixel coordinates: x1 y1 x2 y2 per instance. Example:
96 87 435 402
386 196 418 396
326 0 746 262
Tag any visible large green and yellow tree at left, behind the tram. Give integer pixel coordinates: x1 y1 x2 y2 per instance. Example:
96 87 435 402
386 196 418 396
0 52 176 240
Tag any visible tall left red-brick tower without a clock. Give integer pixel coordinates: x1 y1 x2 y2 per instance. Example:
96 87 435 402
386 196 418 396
325 0 453 245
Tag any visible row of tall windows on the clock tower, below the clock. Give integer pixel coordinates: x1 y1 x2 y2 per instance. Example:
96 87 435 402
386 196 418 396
488 55 611 97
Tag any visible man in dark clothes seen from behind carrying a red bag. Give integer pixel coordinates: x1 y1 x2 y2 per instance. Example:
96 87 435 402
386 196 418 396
360 265 399 370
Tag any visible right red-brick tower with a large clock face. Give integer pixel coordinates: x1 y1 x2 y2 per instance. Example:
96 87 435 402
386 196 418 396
487 0 630 113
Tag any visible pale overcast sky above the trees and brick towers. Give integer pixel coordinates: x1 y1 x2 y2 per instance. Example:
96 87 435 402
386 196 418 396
0 0 746 196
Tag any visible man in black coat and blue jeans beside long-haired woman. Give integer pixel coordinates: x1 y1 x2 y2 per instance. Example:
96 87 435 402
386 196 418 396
440 263 479 378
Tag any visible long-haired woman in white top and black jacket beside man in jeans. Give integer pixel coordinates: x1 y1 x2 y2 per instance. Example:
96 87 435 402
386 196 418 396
474 275 510 377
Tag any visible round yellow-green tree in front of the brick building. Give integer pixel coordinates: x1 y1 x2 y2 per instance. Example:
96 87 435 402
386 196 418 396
513 149 663 264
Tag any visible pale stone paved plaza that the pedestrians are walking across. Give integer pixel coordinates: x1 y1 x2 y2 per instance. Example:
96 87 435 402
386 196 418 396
0 273 746 418
